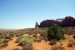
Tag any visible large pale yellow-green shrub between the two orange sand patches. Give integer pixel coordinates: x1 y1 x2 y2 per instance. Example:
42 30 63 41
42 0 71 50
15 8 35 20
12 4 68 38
17 34 33 50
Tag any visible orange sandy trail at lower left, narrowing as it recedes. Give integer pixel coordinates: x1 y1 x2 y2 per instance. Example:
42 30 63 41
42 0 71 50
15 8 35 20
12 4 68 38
0 37 21 50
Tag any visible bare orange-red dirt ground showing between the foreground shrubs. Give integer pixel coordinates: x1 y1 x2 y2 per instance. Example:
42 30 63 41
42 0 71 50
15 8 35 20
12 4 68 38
0 37 75 50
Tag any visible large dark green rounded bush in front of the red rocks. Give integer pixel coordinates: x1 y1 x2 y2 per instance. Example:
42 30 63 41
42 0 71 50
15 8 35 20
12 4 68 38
47 26 65 40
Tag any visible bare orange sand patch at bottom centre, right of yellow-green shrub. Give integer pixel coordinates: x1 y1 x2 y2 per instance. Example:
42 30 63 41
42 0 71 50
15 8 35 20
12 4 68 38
33 41 50 50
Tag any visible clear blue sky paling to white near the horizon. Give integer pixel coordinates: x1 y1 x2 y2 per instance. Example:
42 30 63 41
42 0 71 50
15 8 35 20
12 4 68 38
0 0 75 29
